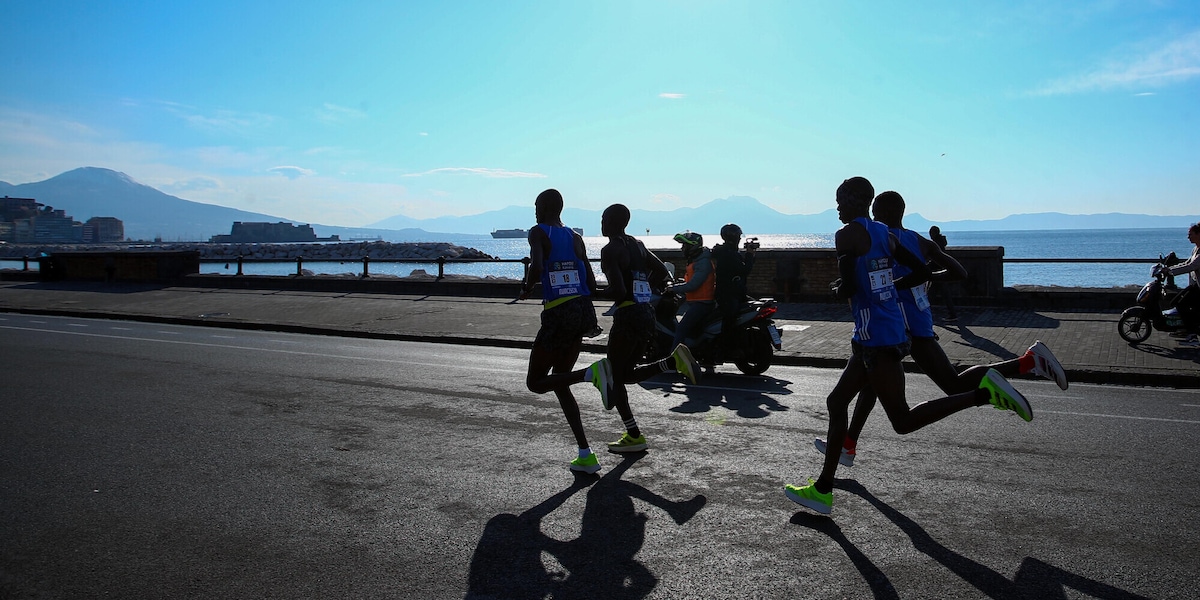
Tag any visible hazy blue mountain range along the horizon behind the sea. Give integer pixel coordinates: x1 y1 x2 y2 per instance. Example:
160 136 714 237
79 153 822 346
0 167 1200 241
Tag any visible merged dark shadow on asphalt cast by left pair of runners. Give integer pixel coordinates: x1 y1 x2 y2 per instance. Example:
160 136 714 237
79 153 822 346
466 452 708 600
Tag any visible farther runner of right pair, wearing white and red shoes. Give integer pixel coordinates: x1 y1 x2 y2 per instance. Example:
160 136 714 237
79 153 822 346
814 192 1068 467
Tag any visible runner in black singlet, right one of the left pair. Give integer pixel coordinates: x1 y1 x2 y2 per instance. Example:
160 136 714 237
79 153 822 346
589 204 700 452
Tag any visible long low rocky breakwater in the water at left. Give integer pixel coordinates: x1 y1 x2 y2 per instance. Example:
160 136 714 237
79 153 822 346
0 241 496 260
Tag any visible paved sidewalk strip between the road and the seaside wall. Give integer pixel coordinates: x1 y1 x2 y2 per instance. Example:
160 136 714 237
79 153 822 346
0 281 1200 388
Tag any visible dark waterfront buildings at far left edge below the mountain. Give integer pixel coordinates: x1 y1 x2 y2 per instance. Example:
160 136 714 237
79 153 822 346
0 196 125 244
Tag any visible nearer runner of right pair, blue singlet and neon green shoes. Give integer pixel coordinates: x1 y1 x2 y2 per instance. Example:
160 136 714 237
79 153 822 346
784 178 1033 515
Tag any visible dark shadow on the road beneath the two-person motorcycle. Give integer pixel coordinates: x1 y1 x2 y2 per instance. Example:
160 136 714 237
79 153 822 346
668 373 792 419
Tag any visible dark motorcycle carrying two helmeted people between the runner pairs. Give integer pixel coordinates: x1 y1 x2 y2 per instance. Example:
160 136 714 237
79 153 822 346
646 294 784 376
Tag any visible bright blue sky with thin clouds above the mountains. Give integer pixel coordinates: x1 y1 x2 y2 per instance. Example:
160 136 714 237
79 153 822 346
0 0 1200 227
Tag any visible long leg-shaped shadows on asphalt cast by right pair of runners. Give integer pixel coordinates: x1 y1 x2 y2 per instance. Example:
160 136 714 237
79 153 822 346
792 479 1145 600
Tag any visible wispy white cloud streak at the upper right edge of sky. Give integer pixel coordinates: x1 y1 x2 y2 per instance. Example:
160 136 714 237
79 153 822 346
1031 31 1200 96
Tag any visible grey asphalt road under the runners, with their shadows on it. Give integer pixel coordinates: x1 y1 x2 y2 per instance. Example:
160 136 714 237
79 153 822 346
0 314 1200 599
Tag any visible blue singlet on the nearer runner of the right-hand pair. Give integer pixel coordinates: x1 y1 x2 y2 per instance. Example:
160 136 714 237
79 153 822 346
850 217 908 347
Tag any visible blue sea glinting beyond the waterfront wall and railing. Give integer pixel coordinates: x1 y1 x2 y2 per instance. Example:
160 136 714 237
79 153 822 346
0 223 1193 288
